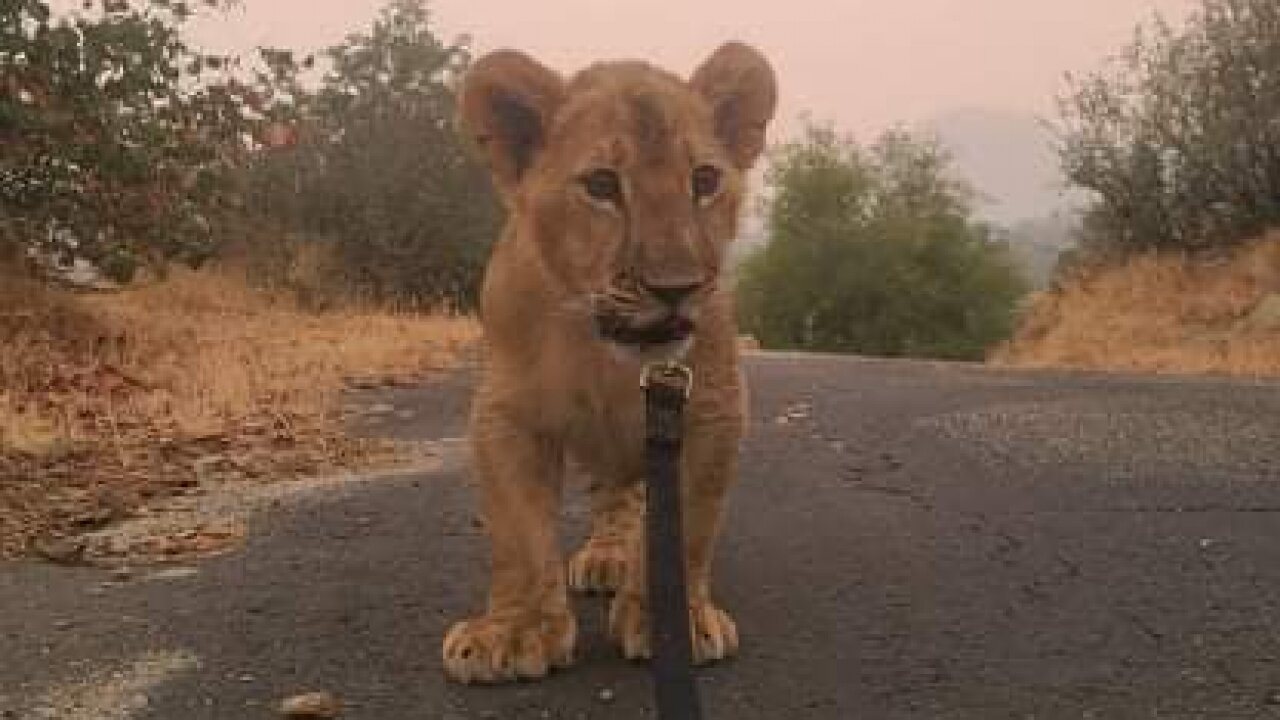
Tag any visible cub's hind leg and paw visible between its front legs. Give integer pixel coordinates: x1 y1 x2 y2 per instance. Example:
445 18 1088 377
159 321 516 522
568 479 644 593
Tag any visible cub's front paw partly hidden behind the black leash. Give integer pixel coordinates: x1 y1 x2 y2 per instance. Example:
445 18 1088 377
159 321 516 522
609 594 737 665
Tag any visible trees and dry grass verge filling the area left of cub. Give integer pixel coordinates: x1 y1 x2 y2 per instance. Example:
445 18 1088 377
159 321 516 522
0 0 488 556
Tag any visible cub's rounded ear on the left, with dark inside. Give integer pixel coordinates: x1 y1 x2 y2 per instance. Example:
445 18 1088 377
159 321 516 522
458 50 564 195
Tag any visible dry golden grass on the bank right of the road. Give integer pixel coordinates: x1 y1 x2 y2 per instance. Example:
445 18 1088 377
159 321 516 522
995 234 1280 377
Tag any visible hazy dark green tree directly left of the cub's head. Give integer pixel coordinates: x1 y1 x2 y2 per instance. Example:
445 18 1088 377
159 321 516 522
249 0 502 309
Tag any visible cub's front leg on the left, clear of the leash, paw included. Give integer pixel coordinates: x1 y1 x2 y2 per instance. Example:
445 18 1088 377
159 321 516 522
443 412 577 683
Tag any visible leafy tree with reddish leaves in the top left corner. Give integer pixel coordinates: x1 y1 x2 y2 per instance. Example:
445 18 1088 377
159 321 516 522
0 0 261 279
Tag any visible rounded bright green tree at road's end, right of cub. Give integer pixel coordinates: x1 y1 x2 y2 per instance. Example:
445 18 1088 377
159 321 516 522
739 128 1023 359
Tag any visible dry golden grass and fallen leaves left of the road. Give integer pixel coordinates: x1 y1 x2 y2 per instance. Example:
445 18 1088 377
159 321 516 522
0 272 475 555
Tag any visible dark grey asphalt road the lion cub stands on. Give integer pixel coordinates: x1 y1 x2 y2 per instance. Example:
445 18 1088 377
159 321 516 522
0 356 1280 720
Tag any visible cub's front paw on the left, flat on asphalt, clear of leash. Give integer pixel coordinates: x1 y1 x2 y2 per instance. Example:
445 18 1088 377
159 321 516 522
444 615 577 684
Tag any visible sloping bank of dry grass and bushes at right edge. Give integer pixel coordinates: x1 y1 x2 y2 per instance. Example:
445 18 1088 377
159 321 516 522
998 0 1280 375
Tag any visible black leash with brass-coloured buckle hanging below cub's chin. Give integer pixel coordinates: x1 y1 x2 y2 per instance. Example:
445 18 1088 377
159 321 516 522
640 363 703 720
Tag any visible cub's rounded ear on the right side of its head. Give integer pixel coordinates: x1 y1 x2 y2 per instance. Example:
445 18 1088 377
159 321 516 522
689 42 778 170
